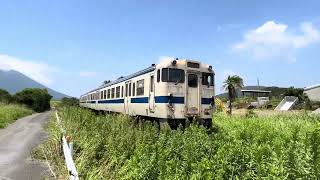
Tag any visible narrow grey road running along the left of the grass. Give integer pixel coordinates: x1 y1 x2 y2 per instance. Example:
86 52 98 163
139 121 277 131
0 112 50 180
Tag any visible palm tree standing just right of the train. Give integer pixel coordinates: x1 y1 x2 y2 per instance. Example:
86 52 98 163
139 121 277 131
223 75 243 115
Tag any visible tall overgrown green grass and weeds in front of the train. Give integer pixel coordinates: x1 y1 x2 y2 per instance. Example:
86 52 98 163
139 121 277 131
39 108 320 179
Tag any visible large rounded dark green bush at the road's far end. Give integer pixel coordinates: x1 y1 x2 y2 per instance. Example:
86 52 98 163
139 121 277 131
14 88 52 112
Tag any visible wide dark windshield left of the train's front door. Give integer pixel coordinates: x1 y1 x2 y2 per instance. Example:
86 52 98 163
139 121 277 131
162 68 184 83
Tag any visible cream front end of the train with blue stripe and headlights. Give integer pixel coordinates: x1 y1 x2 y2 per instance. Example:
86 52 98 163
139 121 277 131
155 59 215 129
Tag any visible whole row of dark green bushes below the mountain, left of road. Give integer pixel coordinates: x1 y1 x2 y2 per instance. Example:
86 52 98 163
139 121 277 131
0 88 52 112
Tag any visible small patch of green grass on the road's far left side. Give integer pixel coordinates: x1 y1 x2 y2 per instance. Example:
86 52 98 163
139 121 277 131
0 103 33 129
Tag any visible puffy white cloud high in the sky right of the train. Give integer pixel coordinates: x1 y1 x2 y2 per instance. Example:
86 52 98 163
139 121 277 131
232 21 320 61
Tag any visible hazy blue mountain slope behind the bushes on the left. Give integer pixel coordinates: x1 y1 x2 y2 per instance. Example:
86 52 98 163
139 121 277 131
0 70 69 100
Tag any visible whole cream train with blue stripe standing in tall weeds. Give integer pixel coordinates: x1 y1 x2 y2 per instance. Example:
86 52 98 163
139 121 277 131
80 59 215 128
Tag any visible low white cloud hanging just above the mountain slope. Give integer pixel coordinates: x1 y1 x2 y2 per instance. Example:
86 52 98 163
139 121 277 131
0 54 53 85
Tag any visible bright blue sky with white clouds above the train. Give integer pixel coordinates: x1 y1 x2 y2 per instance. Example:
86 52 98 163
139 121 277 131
0 0 320 96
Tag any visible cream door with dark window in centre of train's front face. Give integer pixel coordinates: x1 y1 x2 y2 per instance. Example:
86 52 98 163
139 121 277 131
186 73 200 115
